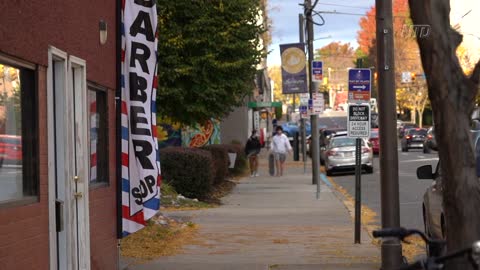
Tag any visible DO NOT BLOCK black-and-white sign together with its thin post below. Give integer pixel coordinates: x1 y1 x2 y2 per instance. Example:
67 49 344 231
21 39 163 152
347 103 371 244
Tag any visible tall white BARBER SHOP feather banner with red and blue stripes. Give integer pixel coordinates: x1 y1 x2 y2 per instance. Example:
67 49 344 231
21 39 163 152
120 0 161 236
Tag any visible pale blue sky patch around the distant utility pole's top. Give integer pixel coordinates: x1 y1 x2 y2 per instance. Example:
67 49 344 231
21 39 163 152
267 0 375 66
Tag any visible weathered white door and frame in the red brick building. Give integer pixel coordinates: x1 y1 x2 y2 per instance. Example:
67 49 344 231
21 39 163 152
47 48 90 270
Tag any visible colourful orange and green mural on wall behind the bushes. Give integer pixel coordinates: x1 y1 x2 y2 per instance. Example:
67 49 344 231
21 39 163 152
182 119 220 147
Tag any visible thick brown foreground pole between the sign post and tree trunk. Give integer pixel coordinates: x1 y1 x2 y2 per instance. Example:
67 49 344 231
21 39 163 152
375 0 402 270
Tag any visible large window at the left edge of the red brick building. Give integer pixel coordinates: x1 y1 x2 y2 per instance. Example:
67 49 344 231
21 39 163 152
0 62 38 204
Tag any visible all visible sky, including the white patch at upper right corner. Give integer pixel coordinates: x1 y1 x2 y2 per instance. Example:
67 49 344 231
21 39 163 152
267 0 480 66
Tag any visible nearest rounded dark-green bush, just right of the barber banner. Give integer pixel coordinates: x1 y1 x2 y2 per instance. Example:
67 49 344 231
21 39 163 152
160 147 214 199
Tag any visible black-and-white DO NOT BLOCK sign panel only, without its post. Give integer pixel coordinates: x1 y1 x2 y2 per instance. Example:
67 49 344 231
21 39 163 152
347 104 371 138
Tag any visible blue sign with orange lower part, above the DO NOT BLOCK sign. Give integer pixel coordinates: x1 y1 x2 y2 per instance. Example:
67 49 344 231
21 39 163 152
348 68 372 102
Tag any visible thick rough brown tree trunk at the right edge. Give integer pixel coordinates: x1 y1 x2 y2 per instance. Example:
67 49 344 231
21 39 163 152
409 0 480 270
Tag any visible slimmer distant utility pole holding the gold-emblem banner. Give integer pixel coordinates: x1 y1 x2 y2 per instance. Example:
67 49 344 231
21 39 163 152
305 0 320 190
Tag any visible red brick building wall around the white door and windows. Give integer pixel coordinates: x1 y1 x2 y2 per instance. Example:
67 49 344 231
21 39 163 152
0 0 117 270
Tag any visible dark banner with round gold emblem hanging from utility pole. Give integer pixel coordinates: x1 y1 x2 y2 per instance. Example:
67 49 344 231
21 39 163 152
280 43 308 94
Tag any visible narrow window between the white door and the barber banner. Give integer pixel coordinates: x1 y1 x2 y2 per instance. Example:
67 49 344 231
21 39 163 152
87 85 108 184
